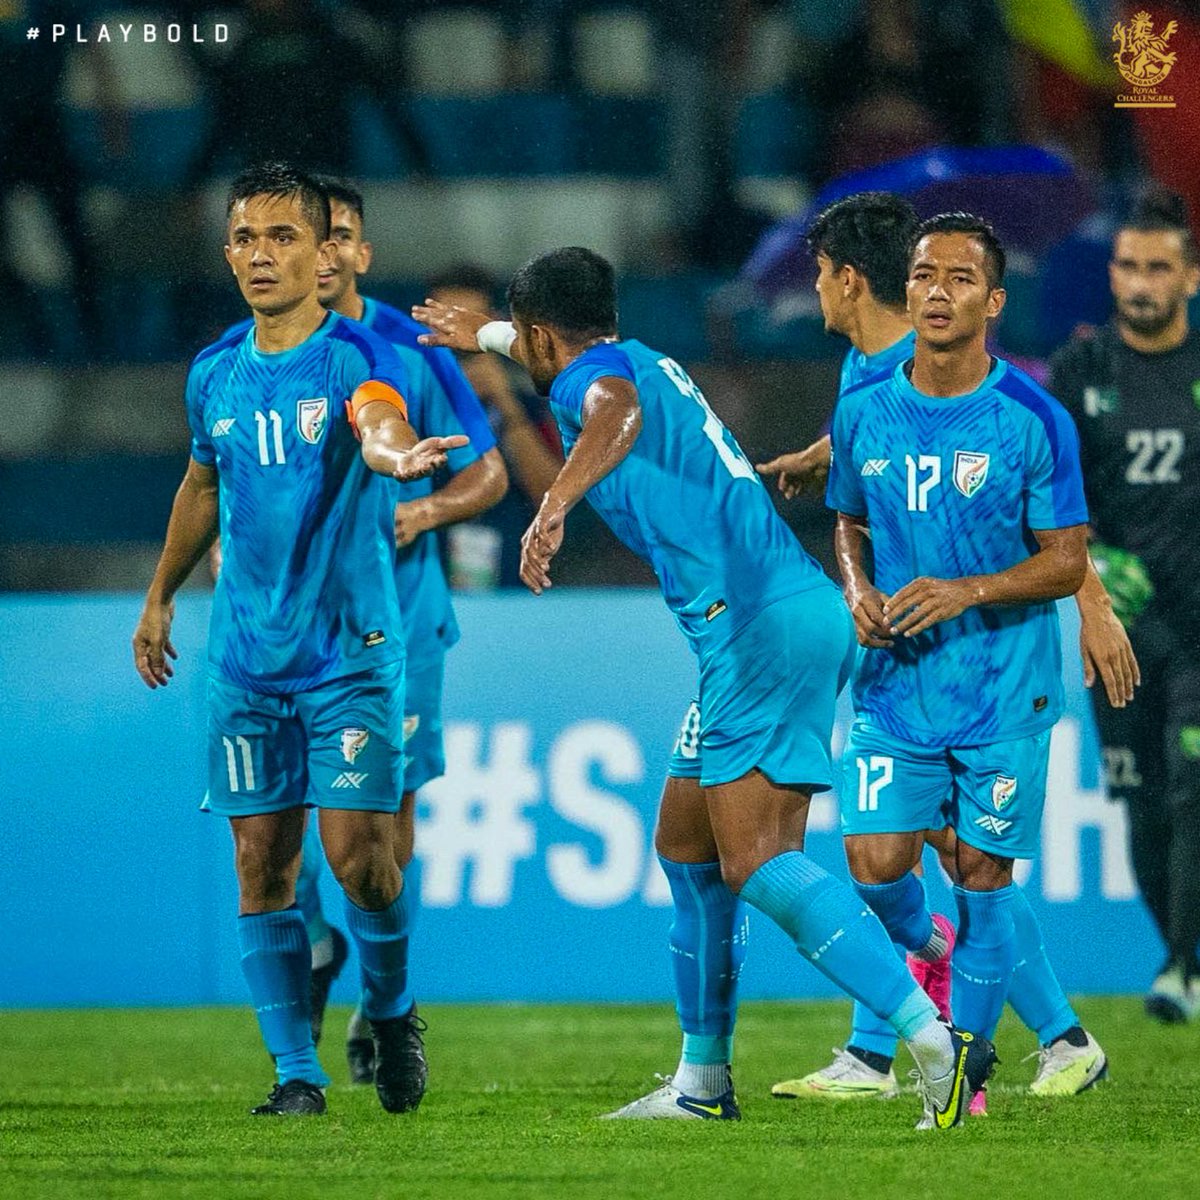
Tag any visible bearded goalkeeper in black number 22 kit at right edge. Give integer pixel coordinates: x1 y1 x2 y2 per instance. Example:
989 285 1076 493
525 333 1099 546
1050 191 1200 1021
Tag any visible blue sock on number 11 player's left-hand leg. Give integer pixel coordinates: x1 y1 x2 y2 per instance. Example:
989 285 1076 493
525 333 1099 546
238 906 329 1087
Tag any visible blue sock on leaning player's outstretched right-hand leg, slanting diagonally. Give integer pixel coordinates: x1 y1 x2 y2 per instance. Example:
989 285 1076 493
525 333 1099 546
742 850 937 1039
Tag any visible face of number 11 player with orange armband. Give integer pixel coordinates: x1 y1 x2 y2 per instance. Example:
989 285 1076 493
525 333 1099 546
226 196 330 316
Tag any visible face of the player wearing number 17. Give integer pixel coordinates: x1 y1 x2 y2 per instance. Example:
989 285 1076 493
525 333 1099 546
908 233 1004 349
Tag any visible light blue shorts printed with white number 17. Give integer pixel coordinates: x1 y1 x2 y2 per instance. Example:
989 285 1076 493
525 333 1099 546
840 718 1050 858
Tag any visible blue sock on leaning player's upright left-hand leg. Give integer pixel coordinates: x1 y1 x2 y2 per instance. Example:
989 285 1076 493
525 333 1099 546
659 856 749 1096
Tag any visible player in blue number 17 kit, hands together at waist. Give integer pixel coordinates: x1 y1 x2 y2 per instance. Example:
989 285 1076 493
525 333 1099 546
828 212 1106 1113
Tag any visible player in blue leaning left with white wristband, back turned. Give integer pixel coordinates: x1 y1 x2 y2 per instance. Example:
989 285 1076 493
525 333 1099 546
414 247 994 1128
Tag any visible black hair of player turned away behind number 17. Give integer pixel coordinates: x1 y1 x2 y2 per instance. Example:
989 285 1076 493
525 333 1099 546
804 192 917 307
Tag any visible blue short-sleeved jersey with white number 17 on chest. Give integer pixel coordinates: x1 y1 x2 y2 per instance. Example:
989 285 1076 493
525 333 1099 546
827 360 1087 746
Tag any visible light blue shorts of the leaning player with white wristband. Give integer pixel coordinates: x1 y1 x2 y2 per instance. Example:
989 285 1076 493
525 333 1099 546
667 586 854 792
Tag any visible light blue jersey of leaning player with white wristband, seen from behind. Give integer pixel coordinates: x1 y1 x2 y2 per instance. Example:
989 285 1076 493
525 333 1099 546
550 341 832 655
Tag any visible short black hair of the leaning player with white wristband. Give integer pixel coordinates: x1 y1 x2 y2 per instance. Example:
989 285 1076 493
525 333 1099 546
509 246 617 338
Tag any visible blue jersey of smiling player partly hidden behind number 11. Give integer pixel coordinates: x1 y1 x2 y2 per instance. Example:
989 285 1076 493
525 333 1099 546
362 291 496 679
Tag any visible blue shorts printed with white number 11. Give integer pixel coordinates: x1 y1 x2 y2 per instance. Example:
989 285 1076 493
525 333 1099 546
205 661 404 817
